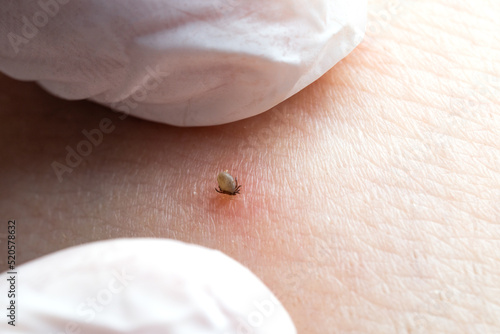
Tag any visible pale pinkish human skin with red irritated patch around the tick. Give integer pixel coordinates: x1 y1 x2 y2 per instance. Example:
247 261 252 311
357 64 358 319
0 0 500 334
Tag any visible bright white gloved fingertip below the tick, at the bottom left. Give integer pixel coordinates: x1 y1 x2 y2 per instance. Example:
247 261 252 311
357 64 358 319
0 239 296 334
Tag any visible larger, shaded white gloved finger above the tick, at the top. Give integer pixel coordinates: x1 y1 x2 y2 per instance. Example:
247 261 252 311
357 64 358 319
0 0 366 126
